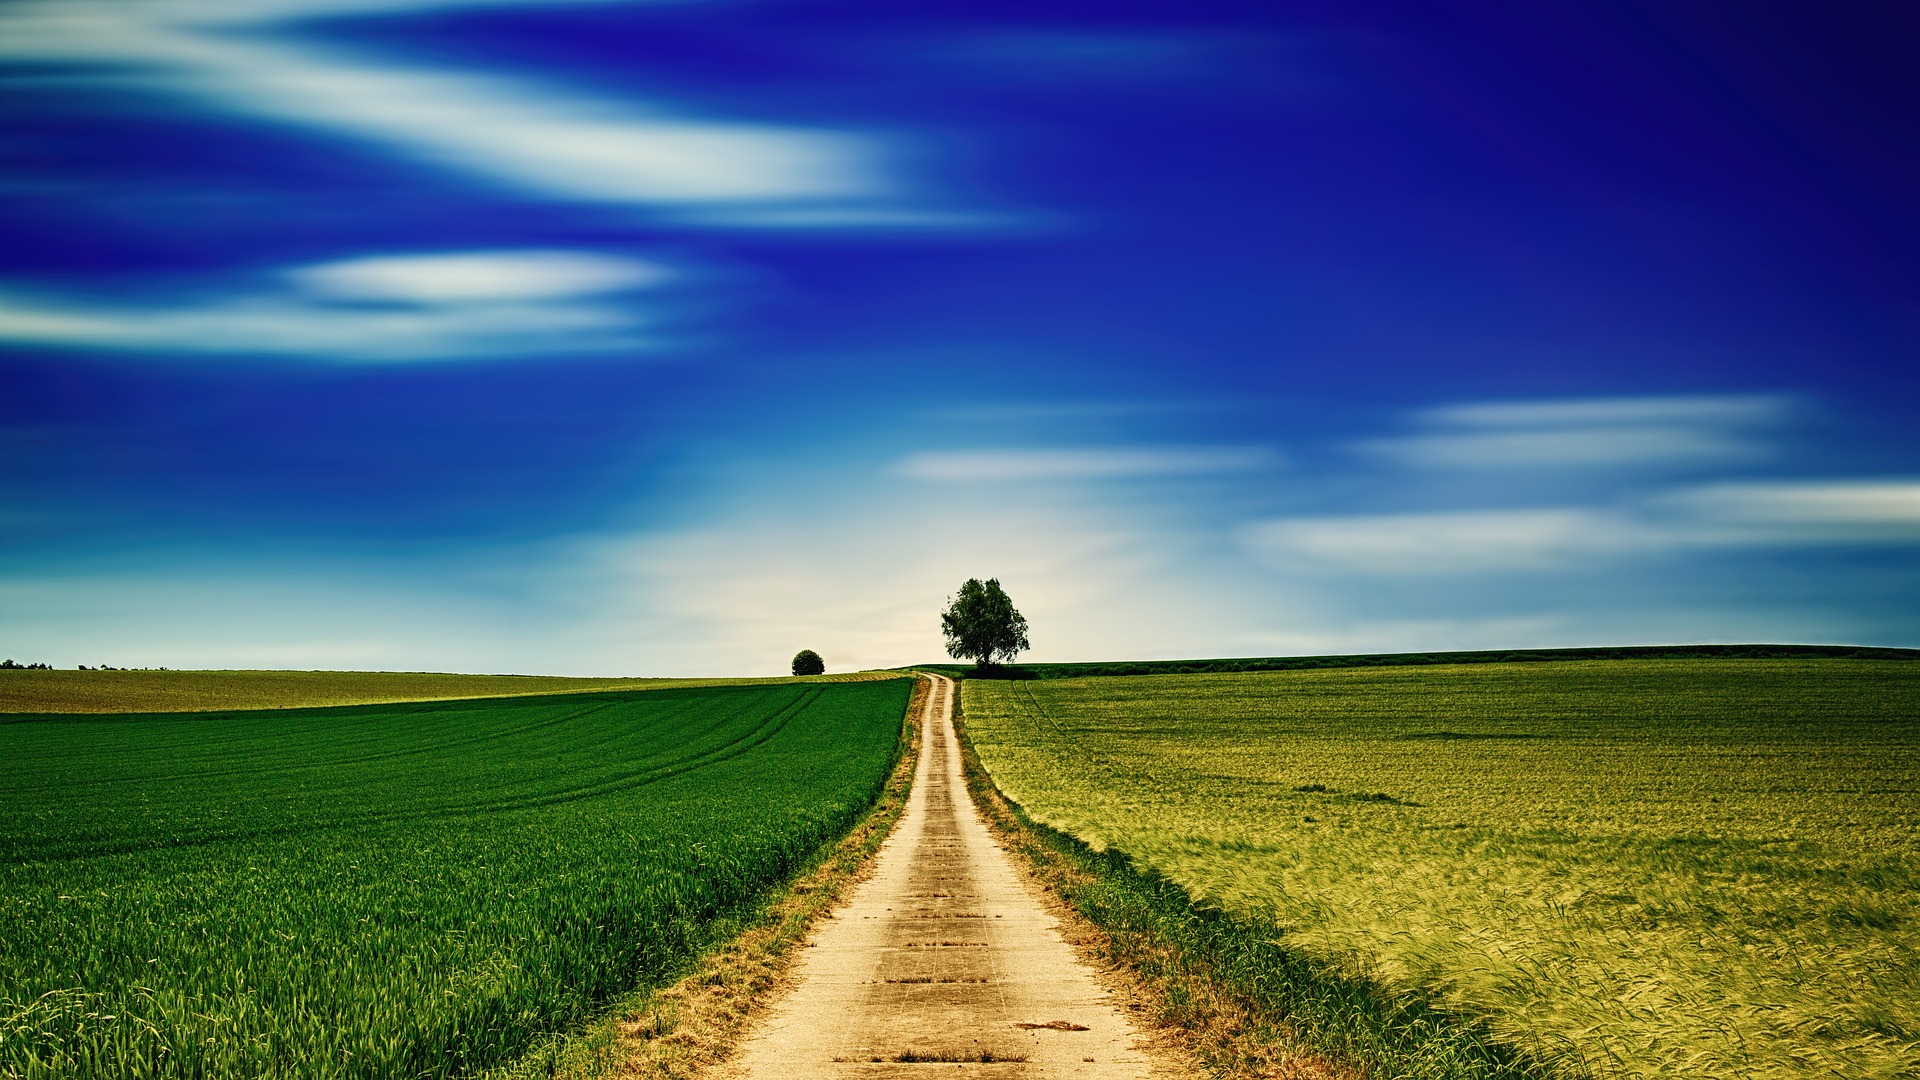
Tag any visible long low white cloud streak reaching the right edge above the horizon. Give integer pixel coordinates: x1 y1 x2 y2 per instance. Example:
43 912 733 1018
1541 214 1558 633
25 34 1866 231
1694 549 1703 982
1240 479 1920 577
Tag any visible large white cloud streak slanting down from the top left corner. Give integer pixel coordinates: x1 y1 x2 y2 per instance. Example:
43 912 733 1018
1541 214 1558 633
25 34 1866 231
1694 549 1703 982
0 0 914 229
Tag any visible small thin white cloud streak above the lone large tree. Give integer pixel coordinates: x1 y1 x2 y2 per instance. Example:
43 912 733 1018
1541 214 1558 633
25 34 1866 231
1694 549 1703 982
893 446 1281 482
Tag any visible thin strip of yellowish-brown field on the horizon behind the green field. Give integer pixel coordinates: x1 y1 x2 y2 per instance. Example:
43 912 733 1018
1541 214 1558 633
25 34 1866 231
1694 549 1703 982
0 669 900 713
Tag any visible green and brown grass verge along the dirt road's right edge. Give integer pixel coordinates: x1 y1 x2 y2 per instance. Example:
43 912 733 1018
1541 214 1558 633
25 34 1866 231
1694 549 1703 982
954 680 1576 1080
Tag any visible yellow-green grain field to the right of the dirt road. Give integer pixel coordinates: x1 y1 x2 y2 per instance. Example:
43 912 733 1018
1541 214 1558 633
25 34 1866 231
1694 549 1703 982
964 659 1920 1078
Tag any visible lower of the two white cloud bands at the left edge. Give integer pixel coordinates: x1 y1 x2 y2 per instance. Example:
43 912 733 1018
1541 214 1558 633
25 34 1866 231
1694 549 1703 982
0 252 670 361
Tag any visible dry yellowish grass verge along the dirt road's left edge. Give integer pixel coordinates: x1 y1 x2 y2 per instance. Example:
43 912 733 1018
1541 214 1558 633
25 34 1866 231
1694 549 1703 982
484 678 929 1080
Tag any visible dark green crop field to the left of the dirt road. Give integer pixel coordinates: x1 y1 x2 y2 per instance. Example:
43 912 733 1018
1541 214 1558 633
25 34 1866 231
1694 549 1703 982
0 673 910 1078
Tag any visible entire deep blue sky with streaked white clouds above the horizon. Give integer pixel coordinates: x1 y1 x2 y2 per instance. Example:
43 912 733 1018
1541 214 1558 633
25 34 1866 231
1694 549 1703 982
0 0 1920 675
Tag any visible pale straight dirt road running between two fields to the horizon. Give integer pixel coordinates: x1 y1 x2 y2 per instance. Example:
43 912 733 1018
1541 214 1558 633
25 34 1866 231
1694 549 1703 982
728 676 1171 1080
